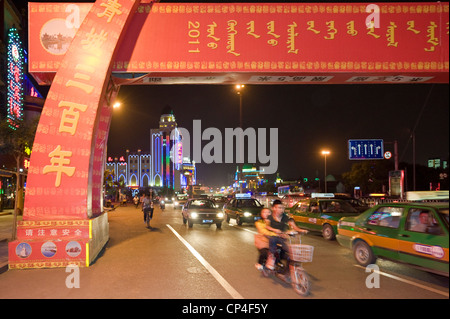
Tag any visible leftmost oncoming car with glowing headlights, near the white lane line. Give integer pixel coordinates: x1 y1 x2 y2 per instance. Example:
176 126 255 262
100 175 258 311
181 198 224 229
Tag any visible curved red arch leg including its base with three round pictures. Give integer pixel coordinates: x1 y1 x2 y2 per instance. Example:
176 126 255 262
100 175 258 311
9 0 139 269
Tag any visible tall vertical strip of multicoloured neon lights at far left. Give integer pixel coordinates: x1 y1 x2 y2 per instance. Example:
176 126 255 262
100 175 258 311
6 28 24 128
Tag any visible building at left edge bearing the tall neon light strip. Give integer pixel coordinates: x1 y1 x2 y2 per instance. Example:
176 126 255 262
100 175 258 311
0 0 44 212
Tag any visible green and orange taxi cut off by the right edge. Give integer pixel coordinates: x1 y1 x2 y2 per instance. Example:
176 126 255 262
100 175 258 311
336 202 449 277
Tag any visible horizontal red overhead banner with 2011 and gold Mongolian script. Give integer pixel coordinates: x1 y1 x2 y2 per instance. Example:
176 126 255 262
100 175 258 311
30 2 449 84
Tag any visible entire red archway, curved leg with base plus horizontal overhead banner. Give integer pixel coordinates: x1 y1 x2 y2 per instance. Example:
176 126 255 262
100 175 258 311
9 0 449 269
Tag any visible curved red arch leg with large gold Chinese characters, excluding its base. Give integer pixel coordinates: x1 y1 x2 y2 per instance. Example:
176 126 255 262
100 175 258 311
24 0 138 220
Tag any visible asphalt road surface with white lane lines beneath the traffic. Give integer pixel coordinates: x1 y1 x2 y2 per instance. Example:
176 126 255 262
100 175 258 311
0 205 449 299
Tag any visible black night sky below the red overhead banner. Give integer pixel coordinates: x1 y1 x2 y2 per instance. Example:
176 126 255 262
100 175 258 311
19 1 449 186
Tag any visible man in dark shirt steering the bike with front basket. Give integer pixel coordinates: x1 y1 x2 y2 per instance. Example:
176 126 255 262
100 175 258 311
266 199 308 269
